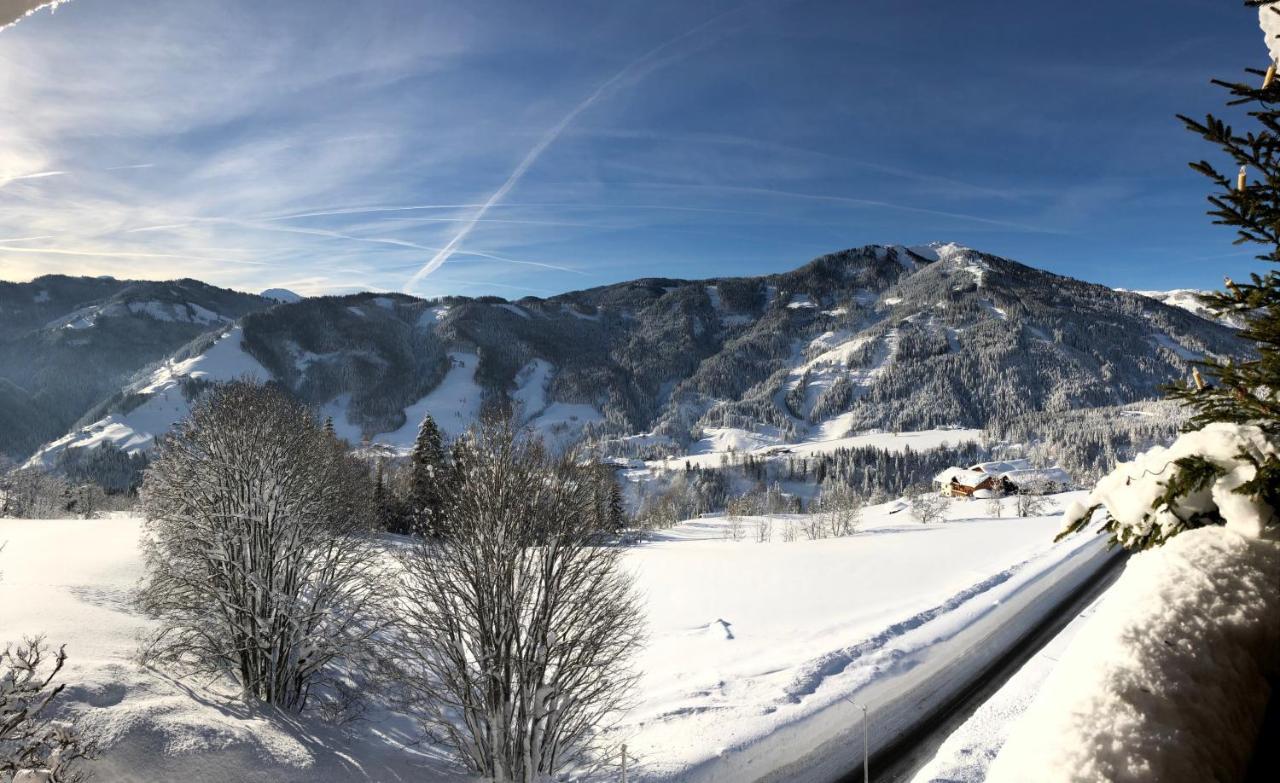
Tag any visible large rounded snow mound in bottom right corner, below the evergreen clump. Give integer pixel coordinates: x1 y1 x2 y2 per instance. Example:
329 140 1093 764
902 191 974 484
987 526 1280 783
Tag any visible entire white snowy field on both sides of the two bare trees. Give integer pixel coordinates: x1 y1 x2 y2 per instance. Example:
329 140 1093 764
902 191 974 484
0 495 1103 783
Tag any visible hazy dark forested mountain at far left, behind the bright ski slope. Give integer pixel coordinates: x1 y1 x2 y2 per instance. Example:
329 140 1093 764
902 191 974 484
0 275 271 458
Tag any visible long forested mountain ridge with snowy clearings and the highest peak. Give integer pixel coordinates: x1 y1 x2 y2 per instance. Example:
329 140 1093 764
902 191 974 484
15 244 1244 463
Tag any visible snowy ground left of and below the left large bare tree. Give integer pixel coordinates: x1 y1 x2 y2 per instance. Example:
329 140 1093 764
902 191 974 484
0 517 463 783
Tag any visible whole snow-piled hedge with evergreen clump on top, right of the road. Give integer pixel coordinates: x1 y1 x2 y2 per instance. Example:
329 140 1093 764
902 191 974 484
988 423 1280 783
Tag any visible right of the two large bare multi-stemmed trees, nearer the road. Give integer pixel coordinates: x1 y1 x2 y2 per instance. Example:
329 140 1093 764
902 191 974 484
397 422 643 782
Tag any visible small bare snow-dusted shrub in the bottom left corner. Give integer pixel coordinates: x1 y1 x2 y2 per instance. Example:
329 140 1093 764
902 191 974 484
0 638 92 783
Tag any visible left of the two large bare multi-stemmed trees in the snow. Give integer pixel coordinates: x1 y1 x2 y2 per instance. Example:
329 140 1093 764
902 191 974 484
140 381 387 710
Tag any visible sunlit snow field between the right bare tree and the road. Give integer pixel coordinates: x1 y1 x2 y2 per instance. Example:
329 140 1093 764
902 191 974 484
622 493 1106 782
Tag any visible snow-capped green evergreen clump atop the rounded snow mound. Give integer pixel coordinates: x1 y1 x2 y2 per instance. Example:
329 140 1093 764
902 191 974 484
1062 422 1280 549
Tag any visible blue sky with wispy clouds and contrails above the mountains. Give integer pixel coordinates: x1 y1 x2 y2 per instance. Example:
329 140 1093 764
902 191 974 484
0 0 1266 298
